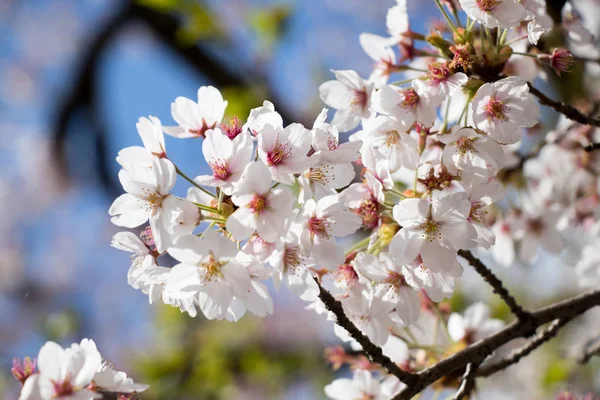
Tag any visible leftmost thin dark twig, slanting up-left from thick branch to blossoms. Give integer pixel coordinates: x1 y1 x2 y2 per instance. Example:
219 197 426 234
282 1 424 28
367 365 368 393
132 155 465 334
315 279 417 385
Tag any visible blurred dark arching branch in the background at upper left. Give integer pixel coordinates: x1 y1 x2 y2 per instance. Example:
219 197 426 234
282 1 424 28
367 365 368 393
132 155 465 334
52 1 307 191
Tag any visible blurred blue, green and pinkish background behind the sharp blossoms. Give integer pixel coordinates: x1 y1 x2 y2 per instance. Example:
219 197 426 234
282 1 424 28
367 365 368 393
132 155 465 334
0 0 600 399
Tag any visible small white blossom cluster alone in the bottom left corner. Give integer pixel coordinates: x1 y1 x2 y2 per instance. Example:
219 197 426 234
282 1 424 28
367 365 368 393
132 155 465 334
12 339 148 400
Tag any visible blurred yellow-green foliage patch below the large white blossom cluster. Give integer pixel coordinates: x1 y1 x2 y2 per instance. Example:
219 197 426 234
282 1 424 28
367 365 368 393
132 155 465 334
133 307 331 400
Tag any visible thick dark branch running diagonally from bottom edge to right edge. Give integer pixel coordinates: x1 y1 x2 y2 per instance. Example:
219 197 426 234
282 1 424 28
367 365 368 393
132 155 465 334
394 290 600 400
